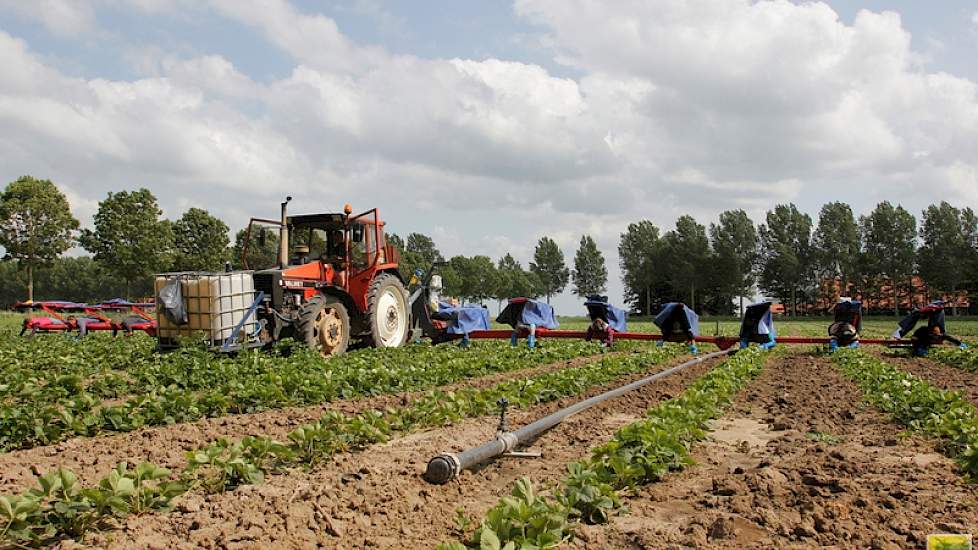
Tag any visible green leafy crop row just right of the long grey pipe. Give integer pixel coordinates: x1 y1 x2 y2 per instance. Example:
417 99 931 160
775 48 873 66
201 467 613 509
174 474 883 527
439 348 767 550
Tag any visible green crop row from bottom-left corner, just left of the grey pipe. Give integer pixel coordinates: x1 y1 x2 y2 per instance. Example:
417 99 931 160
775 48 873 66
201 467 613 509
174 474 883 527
0 346 683 545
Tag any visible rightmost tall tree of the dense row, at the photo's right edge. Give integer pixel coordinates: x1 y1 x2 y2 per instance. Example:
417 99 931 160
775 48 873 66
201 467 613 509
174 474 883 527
917 202 978 313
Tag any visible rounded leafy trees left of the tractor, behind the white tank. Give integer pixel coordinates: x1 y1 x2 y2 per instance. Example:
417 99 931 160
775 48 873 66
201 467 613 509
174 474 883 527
0 176 230 303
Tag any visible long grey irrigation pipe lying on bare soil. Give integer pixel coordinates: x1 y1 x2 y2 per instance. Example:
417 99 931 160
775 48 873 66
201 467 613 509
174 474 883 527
424 348 737 485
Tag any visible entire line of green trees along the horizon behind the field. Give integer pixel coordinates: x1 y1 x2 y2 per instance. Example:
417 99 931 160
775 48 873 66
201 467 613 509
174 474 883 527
0 176 978 314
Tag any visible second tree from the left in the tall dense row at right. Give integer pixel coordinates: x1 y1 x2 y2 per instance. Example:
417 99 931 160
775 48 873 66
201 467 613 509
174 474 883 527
660 215 710 309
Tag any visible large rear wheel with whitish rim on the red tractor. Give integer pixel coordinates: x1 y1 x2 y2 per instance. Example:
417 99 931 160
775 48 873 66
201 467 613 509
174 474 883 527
366 273 410 348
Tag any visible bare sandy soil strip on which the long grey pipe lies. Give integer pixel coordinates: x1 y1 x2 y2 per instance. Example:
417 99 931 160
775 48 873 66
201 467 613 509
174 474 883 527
89 358 715 549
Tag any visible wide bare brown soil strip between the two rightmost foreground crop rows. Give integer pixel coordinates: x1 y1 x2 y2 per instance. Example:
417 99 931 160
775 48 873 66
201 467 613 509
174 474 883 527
588 353 978 548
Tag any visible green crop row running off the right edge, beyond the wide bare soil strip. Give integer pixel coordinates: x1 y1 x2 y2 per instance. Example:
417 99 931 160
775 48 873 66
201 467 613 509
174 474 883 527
833 350 978 479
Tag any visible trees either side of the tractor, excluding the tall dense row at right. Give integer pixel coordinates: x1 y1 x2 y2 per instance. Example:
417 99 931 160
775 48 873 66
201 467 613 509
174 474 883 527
0 176 608 304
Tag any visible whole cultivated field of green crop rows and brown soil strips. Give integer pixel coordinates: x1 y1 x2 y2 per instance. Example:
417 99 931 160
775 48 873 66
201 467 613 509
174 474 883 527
0 320 978 549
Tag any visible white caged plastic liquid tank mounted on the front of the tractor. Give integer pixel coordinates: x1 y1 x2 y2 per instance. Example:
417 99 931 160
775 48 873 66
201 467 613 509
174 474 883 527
154 271 258 345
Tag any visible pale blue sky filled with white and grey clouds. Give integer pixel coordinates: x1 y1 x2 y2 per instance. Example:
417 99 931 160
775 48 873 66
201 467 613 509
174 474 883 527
0 0 978 313
